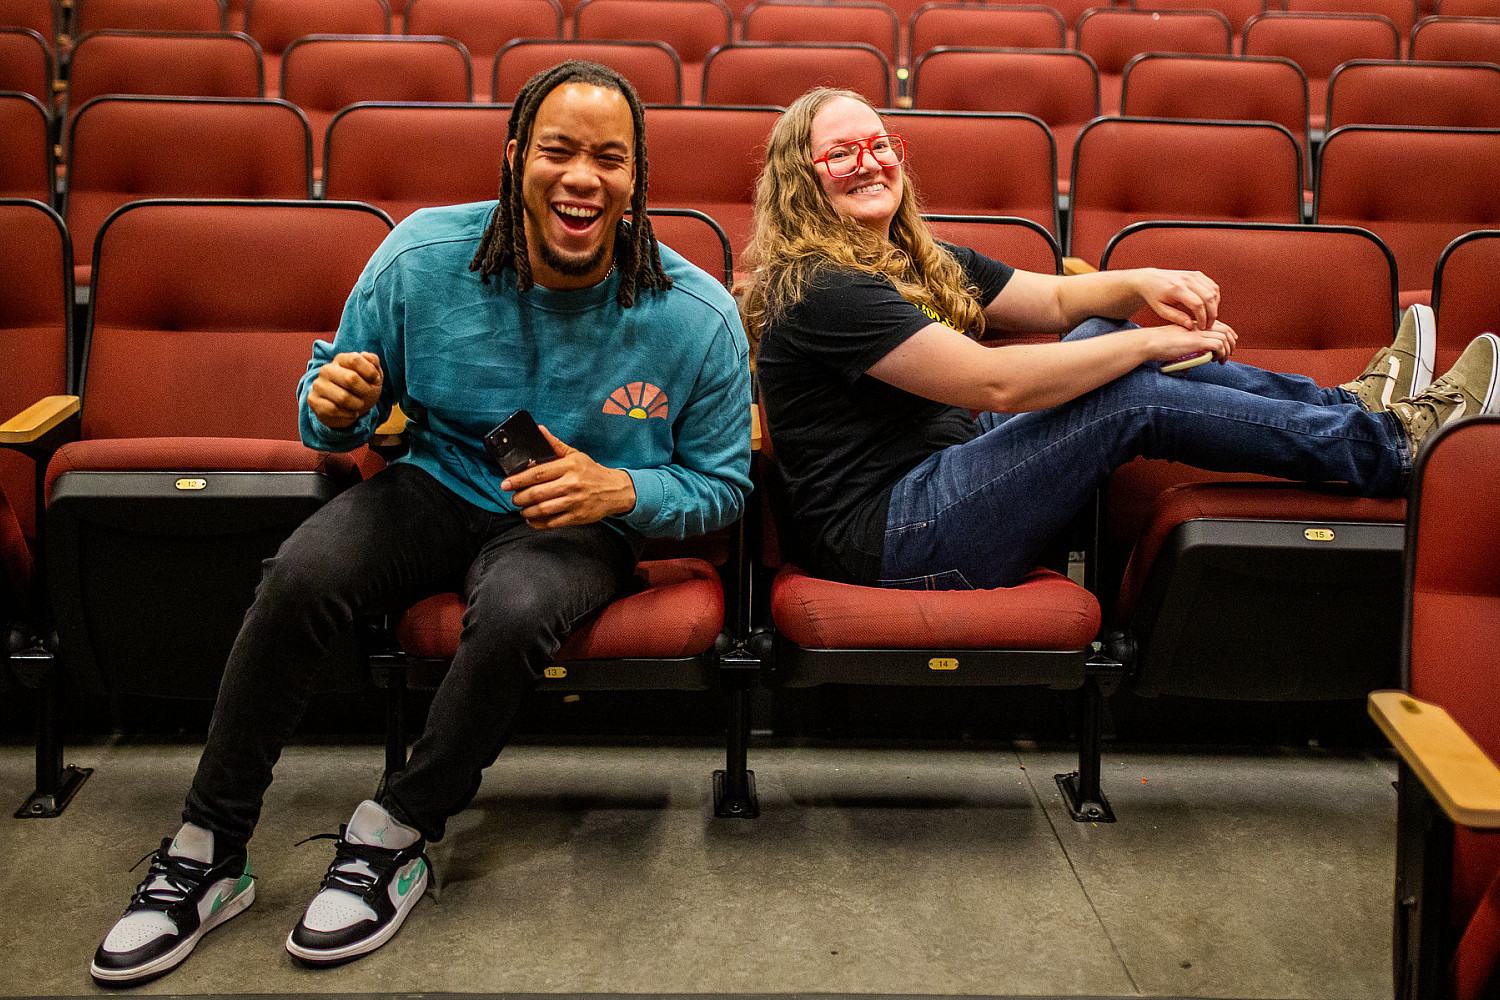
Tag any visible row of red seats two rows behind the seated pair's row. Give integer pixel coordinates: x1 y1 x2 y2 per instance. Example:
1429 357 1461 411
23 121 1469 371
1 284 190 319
11 23 1500 119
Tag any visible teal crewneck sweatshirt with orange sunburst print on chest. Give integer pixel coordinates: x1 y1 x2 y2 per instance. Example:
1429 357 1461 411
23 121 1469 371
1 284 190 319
297 201 750 538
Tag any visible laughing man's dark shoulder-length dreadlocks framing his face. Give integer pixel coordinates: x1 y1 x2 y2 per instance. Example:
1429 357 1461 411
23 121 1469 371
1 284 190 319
470 60 672 309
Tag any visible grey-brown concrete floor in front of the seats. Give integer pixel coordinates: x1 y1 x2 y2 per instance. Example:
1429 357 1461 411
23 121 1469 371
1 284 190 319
0 744 1395 1000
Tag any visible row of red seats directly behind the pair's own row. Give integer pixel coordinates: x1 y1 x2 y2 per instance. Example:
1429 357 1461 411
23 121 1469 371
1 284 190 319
0 96 1500 304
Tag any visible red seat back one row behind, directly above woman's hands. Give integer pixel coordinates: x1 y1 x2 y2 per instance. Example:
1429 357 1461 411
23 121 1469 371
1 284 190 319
1068 118 1302 264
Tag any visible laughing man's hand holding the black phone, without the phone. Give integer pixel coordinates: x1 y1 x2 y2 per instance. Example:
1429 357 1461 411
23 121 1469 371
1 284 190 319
500 427 636 529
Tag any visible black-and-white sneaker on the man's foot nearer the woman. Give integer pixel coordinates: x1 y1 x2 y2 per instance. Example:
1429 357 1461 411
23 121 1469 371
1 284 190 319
287 802 431 966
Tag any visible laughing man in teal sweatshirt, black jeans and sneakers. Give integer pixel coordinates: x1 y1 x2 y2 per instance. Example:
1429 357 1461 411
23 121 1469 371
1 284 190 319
92 56 750 985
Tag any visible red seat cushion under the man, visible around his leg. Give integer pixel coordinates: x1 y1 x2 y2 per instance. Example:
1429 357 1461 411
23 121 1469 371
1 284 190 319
396 559 725 660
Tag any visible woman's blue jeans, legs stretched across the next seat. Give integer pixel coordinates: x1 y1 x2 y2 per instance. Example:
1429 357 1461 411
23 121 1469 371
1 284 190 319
881 319 1412 591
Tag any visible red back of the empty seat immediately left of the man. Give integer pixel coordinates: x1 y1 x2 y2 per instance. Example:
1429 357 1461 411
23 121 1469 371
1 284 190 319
83 201 390 441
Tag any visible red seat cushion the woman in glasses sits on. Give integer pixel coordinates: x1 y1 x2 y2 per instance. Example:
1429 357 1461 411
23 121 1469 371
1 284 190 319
771 565 1100 649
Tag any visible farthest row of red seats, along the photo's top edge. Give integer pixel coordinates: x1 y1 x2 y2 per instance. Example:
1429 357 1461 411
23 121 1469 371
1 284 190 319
0 0 1500 109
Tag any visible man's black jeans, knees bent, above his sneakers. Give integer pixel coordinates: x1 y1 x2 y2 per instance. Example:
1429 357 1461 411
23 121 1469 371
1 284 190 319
183 463 636 856
